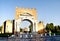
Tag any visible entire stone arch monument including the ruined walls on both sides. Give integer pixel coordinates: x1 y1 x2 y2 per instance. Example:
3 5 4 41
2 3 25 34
2 7 44 33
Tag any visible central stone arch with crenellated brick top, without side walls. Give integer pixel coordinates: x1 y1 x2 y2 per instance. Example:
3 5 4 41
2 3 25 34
15 7 38 32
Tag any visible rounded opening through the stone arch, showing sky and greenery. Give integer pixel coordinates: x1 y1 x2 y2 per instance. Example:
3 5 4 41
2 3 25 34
20 19 33 33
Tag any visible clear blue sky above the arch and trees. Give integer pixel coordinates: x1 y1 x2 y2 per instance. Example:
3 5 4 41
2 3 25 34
0 0 60 25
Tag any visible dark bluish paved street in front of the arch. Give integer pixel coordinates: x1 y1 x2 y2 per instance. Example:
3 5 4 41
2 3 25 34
0 34 60 41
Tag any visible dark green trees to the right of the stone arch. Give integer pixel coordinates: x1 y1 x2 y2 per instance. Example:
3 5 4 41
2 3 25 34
46 23 60 35
